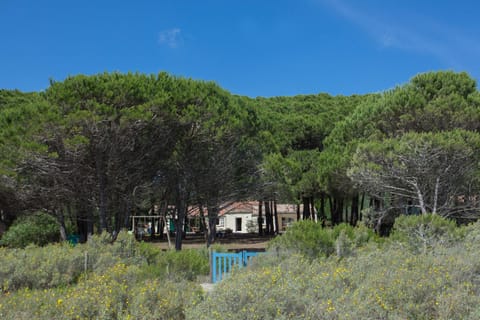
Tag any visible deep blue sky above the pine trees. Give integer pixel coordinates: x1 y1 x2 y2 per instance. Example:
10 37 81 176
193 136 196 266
0 0 480 97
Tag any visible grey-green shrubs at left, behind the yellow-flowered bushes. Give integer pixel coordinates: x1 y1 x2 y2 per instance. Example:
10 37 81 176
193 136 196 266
0 232 147 291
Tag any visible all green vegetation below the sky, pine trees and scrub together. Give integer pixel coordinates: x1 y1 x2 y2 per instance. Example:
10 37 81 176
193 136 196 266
0 71 480 319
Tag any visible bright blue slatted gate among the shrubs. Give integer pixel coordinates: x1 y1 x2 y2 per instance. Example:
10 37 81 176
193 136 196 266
211 251 258 283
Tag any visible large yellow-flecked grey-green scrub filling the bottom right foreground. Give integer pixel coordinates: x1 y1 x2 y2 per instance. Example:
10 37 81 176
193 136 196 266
186 228 480 320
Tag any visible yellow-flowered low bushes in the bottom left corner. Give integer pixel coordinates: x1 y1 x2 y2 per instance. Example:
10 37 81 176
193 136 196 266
0 263 202 320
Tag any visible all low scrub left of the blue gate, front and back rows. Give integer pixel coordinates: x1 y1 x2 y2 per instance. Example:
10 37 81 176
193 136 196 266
0 232 208 319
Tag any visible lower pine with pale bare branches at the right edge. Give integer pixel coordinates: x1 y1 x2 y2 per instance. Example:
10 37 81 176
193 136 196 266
348 130 480 218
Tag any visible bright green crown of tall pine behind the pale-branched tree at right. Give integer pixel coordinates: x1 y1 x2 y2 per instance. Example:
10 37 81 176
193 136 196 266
320 72 480 228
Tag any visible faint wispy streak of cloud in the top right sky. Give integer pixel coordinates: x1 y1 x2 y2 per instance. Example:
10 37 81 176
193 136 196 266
318 0 480 68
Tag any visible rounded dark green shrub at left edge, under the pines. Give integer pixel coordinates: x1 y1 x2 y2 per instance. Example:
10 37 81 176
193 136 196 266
0 212 60 248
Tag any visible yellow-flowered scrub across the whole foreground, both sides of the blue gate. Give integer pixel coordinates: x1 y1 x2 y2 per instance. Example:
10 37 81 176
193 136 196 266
0 217 480 320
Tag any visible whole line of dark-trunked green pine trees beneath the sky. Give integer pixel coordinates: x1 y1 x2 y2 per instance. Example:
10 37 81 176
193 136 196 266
0 72 480 249
